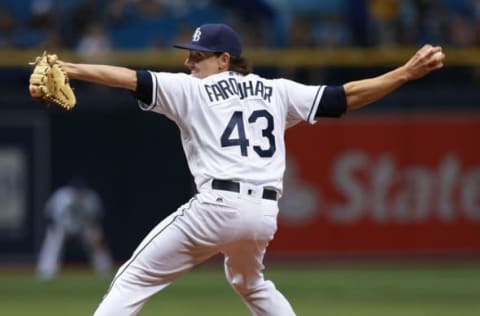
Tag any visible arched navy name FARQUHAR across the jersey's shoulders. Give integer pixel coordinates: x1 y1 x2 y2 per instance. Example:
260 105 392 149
204 78 273 103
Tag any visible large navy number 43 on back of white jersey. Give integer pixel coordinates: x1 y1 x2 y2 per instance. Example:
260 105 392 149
220 110 276 158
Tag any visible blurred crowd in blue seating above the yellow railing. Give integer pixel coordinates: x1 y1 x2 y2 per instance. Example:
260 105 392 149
0 0 480 54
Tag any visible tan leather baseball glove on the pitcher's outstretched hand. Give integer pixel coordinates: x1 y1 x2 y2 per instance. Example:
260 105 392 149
29 51 77 110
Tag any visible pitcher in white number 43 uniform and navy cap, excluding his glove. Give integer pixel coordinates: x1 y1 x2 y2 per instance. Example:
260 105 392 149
60 24 444 316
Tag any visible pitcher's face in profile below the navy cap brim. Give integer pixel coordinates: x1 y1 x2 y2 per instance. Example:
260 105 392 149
185 51 228 79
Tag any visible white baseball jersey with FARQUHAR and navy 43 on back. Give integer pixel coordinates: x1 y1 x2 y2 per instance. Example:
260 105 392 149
139 71 325 194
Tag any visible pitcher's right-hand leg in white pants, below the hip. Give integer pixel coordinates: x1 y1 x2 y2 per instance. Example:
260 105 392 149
225 240 295 316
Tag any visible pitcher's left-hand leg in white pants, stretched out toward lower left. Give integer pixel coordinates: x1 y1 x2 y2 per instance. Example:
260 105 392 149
94 201 214 316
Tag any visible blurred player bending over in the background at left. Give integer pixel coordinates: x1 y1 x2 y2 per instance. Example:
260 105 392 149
37 177 113 280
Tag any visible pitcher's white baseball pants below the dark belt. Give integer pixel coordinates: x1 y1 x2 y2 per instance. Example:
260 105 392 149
94 184 295 316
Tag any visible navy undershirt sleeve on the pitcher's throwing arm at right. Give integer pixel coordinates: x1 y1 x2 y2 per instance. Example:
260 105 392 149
315 86 347 118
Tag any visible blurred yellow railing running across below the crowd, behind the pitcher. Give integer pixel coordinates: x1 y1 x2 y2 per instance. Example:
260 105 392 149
0 48 480 68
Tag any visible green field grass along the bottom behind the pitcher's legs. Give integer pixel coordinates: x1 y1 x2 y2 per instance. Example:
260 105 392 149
0 264 480 316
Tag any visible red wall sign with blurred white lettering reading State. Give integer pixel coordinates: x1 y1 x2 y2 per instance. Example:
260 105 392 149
270 115 480 255
